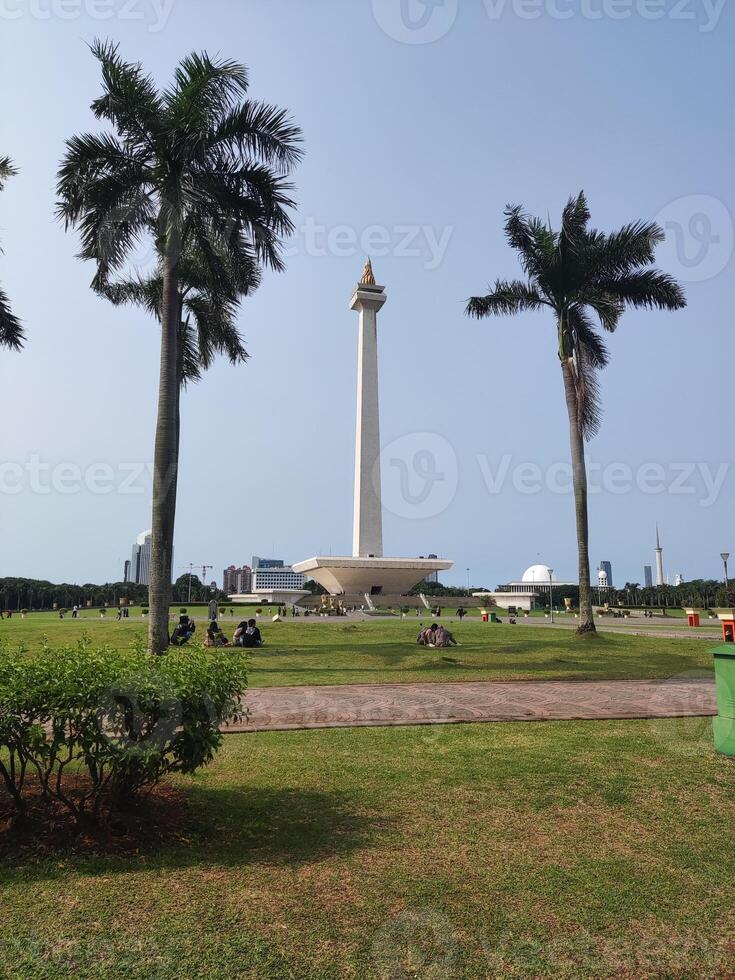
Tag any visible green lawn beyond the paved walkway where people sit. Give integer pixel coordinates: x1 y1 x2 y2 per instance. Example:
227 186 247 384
0 613 716 687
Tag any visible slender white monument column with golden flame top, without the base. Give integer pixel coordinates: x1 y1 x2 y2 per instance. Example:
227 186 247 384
350 259 387 558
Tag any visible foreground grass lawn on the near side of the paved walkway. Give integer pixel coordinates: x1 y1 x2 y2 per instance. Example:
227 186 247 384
0 719 735 980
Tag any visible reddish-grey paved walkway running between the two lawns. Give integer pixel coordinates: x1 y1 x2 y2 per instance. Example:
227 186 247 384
226 676 716 732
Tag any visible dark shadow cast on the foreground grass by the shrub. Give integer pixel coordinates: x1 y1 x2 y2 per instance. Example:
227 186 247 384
0 781 390 888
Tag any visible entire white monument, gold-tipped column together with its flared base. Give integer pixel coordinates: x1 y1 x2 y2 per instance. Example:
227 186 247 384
293 259 454 602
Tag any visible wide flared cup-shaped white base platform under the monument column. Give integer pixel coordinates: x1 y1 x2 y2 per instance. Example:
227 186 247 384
293 555 454 597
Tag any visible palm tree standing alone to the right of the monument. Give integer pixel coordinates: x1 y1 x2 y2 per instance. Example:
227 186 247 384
466 193 686 633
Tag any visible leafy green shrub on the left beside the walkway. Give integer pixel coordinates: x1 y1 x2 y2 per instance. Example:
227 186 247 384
0 638 247 824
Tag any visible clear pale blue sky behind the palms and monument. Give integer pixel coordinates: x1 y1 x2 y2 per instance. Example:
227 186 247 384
0 0 735 586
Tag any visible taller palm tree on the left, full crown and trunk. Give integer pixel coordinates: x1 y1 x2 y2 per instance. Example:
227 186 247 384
58 41 301 653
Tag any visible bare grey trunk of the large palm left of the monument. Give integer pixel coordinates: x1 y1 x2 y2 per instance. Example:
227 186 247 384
148 240 179 653
